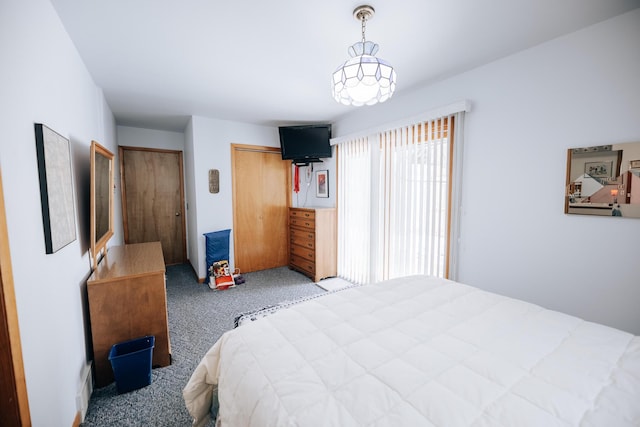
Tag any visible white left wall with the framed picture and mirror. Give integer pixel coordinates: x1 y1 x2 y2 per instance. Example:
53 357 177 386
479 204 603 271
0 0 121 426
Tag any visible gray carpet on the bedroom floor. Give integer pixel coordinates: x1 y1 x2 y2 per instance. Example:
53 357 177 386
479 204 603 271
82 264 324 427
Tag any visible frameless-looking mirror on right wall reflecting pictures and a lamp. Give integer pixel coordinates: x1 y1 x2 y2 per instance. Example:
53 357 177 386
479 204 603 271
564 142 640 218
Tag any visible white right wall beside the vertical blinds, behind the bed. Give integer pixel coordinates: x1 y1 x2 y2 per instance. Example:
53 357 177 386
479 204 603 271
333 9 640 334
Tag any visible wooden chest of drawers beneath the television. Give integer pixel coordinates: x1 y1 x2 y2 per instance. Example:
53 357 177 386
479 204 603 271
289 208 337 282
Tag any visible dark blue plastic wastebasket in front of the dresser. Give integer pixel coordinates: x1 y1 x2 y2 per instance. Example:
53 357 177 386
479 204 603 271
109 335 156 393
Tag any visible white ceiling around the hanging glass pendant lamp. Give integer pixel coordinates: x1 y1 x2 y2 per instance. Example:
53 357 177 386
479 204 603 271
51 0 640 131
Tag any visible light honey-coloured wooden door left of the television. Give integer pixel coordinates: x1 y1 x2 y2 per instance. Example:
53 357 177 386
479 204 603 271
231 144 291 272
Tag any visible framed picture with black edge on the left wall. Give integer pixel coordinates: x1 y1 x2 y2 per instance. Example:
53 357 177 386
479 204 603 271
35 123 76 254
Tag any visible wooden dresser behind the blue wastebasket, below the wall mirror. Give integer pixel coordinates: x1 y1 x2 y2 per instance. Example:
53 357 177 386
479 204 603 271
87 242 171 387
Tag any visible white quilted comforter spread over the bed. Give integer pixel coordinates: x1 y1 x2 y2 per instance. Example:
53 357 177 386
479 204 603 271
183 276 640 427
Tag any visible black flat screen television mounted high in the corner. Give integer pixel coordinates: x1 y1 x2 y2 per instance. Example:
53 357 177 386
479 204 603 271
278 124 331 163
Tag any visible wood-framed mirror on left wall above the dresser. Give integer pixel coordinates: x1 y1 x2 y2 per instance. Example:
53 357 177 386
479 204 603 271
89 141 113 270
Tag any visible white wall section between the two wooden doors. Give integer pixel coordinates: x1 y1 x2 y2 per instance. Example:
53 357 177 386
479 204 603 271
185 116 280 279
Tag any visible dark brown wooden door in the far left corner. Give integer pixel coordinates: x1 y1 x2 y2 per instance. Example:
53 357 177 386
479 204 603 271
119 147 187 265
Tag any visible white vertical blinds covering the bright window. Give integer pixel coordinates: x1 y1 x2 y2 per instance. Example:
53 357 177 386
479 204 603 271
338 113 463 283
